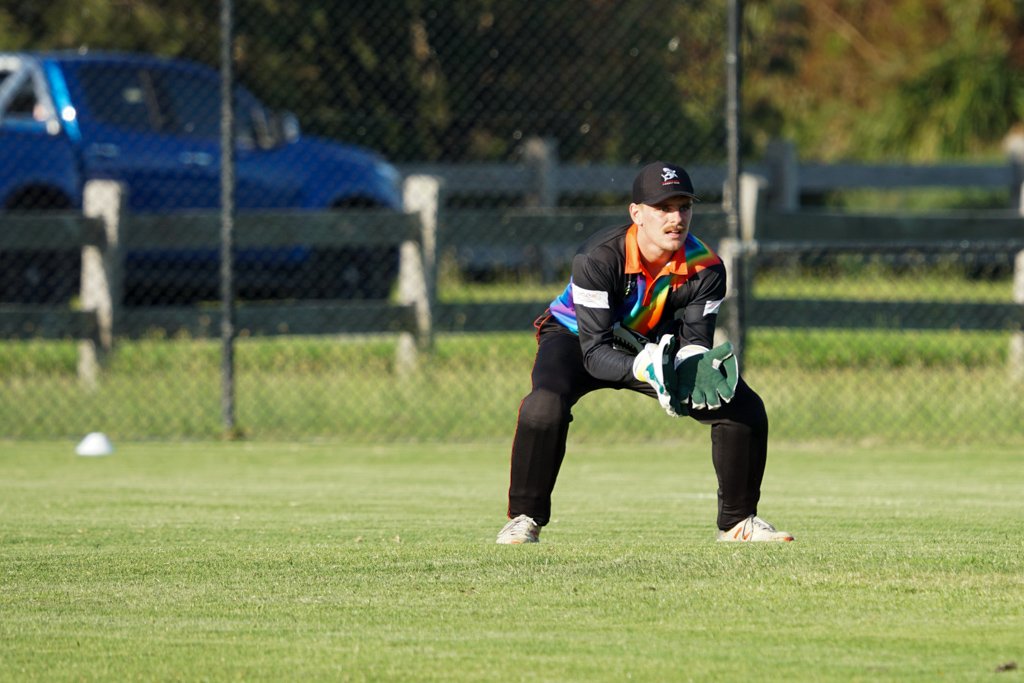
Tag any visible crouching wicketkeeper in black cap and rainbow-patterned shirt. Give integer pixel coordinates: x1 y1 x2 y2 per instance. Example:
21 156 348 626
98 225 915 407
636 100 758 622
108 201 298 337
498 162 793 544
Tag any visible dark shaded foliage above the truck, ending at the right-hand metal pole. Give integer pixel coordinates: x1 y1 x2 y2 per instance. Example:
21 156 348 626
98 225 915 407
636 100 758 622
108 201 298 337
0 0 724 162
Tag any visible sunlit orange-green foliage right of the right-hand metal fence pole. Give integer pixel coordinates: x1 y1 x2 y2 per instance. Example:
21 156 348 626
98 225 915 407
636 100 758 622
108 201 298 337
745 0 1024 161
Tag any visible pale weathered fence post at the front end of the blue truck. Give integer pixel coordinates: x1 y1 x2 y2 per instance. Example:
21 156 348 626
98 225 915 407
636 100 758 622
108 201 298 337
395 175 442 374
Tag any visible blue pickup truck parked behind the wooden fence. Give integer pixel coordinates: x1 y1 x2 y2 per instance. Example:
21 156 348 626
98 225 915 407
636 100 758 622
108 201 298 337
0 52 400 304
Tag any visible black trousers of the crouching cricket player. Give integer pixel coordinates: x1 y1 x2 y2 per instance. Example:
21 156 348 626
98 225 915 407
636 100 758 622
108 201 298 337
508 325 768 529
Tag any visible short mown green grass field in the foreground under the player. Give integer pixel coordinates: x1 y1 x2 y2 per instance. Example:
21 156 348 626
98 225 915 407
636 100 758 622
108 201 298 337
0 434 1024 682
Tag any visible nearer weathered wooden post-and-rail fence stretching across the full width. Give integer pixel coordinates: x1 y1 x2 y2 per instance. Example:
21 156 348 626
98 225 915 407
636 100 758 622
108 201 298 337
0 176 1024 383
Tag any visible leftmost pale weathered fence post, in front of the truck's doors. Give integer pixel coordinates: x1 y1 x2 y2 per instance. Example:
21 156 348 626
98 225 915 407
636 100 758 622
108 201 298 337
78 180 126 389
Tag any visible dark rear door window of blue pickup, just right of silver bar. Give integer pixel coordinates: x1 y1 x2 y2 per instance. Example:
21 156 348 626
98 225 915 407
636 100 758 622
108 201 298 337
79 65 162 132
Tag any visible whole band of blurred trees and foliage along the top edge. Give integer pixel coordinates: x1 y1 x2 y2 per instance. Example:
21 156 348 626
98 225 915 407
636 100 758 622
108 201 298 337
0 0 1024 163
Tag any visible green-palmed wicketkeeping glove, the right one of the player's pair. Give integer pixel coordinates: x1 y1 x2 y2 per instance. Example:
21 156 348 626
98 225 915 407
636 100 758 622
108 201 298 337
675 342 739 410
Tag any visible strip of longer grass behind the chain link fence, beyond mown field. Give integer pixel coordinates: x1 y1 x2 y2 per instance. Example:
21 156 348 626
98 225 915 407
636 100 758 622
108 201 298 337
6 329 1024 445
